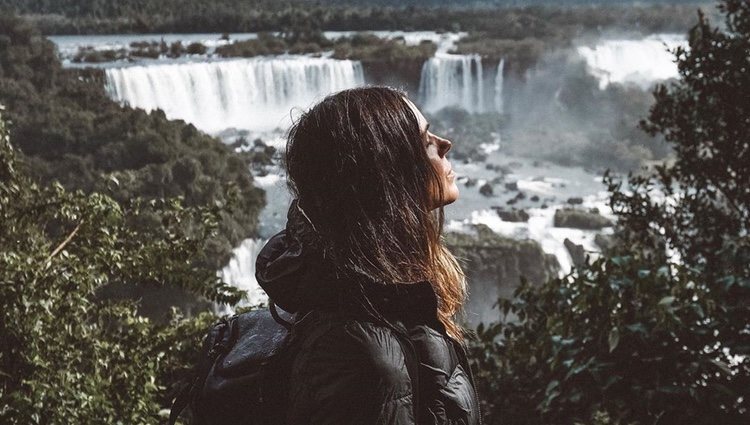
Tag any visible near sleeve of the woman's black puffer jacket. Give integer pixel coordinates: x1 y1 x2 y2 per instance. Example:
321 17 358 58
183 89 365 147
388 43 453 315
288 322 416 425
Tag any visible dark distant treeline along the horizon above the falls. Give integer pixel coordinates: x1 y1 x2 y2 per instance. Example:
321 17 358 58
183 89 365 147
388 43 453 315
0 0 697 34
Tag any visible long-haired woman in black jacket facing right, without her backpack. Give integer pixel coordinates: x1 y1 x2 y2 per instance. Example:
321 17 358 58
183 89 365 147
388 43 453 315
256 87 480 424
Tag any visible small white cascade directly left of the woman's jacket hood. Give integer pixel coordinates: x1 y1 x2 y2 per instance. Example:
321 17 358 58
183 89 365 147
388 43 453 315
219 235 268 313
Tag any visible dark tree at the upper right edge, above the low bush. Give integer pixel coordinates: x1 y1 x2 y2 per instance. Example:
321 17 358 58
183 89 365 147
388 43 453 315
624 1 750 274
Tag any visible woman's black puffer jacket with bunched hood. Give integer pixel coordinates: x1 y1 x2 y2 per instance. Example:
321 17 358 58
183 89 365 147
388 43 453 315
256 225 481 425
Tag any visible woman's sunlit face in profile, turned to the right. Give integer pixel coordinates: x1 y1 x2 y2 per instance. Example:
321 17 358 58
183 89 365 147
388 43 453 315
404 99 458 208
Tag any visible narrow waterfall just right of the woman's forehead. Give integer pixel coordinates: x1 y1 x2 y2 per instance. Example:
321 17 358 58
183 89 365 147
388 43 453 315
419 53 487 112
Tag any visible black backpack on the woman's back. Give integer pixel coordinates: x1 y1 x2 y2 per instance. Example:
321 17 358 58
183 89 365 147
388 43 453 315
169 302 308 425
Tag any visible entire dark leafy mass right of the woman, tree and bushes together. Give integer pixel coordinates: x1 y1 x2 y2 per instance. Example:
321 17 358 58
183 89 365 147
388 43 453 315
471 0 750 425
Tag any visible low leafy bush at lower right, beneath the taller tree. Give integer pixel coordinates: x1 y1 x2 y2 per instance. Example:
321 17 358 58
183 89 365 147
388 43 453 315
471 254 750 424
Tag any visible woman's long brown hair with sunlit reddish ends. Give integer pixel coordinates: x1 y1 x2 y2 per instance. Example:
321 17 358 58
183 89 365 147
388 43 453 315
286 87 466 339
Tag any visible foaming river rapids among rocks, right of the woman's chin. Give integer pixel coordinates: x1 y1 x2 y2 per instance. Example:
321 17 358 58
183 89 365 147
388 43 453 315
445 149 614 274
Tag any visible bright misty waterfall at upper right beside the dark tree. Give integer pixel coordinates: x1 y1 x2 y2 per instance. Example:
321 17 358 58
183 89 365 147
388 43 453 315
578 34 687 89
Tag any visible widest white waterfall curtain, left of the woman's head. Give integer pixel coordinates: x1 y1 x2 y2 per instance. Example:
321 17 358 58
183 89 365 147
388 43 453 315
106 56 364 133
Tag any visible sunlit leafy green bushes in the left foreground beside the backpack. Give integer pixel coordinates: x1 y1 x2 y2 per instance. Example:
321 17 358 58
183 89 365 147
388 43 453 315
0 111 243 424
